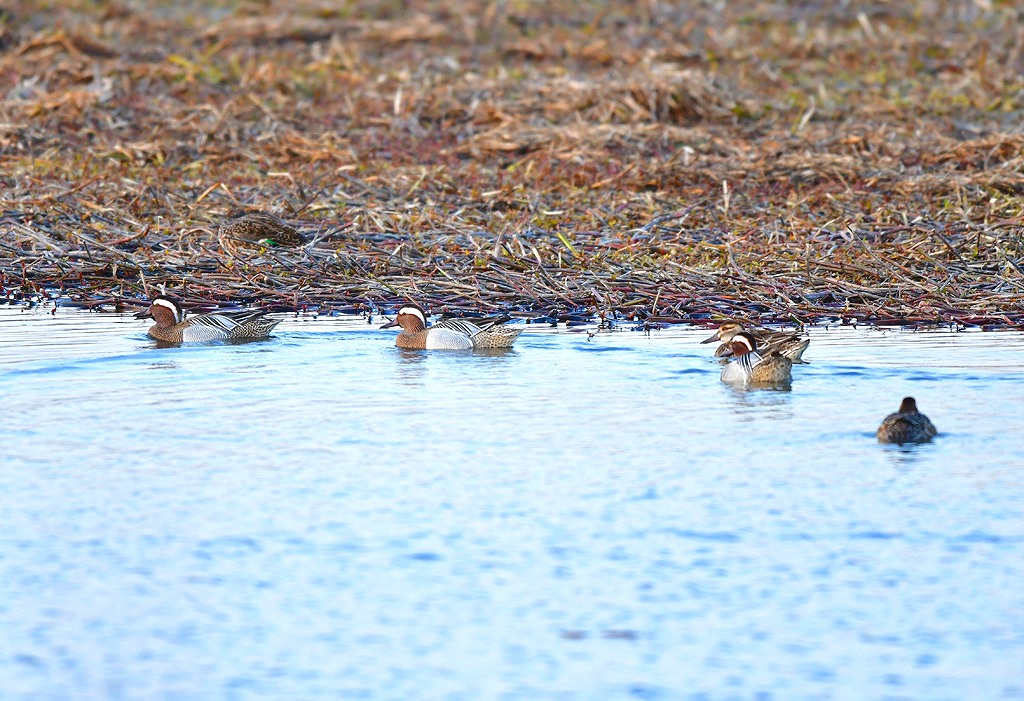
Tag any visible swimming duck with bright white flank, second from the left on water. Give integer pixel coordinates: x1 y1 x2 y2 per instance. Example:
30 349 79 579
381 304 522 350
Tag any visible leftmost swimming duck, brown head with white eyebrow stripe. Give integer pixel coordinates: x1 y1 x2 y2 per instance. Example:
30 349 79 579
135 295 280 343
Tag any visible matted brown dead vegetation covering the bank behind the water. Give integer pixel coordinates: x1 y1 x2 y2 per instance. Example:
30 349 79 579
0 0 1024 326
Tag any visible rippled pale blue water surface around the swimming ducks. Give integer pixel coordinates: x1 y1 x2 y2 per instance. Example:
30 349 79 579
0 307 1024 701
